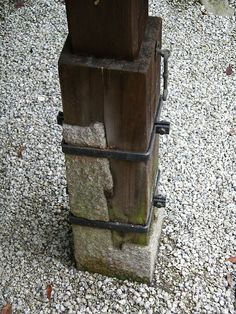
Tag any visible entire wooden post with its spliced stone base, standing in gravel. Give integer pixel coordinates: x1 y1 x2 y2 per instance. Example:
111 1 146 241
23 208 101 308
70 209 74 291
59 0 167 281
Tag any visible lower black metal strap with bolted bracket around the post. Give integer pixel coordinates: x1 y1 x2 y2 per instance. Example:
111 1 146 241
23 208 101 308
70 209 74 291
69 171 165 233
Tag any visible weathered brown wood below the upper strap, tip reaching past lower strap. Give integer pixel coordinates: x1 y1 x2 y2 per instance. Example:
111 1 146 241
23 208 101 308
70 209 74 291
108 136 159 247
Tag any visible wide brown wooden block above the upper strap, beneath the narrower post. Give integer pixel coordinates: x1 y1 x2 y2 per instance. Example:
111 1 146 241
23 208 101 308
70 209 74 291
59 17 161 152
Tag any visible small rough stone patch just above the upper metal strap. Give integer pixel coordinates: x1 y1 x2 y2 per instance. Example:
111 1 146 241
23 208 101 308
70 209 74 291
63 122 106 148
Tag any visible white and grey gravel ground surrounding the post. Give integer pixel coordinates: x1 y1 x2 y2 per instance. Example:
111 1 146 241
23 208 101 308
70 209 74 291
0 0 236 314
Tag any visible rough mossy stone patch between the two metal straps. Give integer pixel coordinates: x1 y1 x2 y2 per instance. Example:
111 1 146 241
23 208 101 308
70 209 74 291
65 155 113 221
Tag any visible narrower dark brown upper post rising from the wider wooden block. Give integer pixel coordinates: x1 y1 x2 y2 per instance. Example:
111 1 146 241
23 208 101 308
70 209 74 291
66 0 148 60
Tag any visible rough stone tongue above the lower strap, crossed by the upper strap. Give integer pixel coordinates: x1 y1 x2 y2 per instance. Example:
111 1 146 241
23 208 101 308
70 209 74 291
63 122 113 221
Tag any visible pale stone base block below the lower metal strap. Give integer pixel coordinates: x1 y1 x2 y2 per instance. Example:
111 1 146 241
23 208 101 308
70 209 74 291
72 208 164 283
